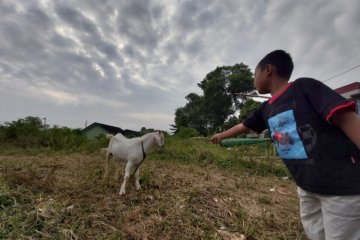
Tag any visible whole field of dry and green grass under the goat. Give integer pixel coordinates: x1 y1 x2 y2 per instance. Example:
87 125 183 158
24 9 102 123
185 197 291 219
0 138 306 240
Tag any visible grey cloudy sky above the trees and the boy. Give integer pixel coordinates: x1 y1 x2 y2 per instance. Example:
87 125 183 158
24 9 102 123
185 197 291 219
0 0 360 130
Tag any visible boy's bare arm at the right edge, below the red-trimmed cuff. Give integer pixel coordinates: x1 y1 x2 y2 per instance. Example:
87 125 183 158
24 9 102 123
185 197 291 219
332 110 360 150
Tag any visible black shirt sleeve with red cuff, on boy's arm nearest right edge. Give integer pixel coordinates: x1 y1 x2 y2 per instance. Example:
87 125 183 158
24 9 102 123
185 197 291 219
297 78 356 121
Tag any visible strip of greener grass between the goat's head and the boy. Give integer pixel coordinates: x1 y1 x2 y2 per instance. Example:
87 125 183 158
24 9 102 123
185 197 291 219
150 137 289 177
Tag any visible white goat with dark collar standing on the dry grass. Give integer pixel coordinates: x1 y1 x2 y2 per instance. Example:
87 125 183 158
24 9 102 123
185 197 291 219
104 132 164 195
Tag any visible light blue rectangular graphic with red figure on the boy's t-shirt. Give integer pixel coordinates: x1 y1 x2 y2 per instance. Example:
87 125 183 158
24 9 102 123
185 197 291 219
268 110 308 160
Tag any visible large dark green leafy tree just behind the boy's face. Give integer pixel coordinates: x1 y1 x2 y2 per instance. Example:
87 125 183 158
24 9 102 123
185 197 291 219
172 63 254 135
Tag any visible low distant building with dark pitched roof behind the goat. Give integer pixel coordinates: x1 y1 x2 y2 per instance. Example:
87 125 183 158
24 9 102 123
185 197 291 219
81 122 140 139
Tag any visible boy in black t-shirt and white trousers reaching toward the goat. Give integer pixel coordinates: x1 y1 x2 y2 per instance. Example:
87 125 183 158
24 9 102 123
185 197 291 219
211 50 360 240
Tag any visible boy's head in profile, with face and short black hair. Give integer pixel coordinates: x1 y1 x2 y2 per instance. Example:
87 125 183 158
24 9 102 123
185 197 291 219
254 50 294 94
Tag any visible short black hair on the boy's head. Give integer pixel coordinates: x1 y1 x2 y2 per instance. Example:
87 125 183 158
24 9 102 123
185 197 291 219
258 50 294 78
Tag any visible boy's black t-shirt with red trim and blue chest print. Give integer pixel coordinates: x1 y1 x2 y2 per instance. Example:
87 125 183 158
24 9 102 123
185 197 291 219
243 78 360 195
